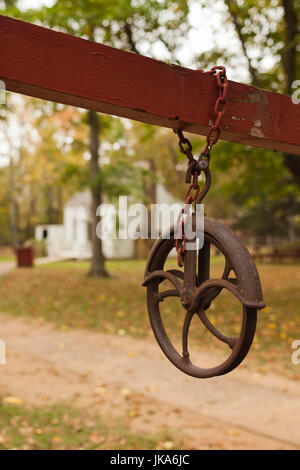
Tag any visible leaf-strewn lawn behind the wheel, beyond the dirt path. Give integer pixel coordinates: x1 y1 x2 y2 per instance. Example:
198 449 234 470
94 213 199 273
0 258 300 373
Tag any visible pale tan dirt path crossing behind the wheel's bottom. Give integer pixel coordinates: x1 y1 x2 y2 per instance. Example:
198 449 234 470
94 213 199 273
0 315 300 449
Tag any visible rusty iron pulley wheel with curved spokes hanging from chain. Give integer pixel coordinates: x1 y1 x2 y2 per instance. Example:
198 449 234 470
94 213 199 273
144 218 264 378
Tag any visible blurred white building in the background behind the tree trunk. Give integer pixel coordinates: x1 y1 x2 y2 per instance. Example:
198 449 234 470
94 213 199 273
35 184 182 259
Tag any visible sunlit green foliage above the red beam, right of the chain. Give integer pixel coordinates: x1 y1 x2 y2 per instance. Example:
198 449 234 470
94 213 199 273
198 0 300 92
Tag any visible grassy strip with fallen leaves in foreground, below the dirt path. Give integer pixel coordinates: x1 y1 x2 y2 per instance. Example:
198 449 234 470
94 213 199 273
0 397 186 450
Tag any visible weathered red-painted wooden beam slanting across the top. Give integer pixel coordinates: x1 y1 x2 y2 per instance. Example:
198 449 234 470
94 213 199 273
0 15 300 155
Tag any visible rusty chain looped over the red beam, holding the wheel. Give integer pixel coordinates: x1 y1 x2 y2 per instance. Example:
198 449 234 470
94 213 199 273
174 65 228 267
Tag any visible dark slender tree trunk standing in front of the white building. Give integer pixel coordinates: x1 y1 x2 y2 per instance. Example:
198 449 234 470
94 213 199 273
88 111 108 277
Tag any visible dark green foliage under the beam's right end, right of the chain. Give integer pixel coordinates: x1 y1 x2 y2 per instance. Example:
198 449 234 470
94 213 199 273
210 142 300 236
